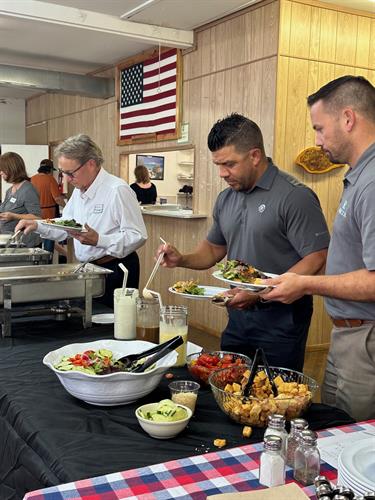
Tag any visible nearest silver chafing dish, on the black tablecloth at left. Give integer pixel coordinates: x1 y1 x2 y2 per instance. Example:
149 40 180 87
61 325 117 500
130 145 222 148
0 264 112 337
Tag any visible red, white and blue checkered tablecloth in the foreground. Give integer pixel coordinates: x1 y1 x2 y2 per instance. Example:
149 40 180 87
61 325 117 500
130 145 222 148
24 420 375 500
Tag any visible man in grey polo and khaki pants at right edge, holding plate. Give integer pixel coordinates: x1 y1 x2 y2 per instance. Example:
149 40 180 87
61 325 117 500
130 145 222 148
266 76 375 420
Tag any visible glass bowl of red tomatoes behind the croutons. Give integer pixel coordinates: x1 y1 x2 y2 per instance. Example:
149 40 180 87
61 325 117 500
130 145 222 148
186 351 251 385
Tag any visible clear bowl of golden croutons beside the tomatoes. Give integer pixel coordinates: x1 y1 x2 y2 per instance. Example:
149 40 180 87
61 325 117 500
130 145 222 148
208 365 318 427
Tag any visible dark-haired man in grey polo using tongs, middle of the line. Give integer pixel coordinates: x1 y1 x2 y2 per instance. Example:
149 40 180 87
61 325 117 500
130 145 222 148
159 114 329 370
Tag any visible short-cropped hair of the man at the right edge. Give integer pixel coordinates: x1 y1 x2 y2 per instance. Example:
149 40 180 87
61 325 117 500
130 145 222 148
307 75 375 123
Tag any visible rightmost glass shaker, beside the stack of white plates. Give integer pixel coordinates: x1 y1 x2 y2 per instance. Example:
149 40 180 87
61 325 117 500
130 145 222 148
293 430 320 486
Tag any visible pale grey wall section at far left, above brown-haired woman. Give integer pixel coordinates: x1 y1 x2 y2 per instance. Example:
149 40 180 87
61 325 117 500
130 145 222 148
0 98 26 144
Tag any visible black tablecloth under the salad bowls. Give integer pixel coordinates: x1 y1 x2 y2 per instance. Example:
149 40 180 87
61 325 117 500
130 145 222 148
0 319 353 500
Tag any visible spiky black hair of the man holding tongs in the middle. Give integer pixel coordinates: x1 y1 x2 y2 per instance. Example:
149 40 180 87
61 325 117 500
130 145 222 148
207 113 265 154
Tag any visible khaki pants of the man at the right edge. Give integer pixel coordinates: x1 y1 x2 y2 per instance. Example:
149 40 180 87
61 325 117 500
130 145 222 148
322 322 375 421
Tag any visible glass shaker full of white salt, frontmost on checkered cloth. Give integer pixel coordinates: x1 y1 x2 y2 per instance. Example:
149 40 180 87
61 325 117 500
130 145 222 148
259 435 285 487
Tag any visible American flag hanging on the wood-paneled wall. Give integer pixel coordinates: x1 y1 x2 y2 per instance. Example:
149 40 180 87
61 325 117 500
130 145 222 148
120 49 177 140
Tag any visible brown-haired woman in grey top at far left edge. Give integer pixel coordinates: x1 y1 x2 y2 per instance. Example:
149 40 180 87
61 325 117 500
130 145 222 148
0 152 41 247
